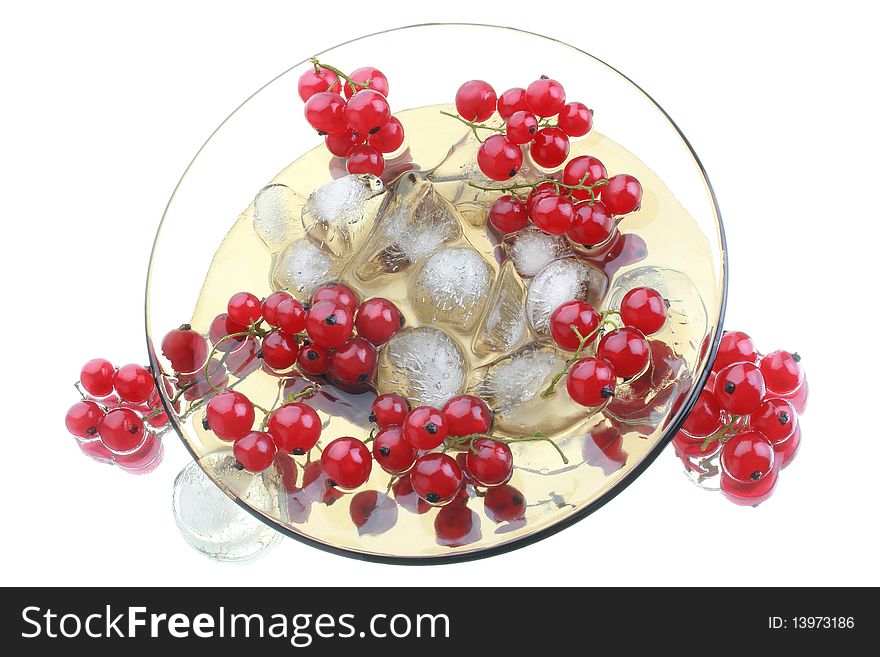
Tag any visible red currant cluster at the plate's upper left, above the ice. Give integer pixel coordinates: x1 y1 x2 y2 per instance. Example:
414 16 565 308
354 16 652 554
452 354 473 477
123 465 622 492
298 58 404 176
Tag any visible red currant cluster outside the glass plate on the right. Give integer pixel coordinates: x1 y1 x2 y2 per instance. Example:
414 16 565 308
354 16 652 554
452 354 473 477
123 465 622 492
673 331 807 506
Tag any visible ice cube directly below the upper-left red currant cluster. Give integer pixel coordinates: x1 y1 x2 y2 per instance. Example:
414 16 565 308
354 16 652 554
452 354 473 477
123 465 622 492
302 174 385 256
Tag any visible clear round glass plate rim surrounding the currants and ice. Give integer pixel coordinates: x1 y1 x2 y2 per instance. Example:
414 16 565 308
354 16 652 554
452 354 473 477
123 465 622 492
146 25 726 563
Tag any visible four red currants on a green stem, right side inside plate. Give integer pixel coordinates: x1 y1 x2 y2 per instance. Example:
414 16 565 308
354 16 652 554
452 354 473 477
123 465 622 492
543 287 668 408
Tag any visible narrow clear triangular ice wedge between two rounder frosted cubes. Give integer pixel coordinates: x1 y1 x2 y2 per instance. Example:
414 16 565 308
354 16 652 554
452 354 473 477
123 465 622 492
473 261 529 356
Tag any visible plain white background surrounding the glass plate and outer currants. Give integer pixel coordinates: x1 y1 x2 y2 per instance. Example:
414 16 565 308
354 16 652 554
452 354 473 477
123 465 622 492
0 0 880 584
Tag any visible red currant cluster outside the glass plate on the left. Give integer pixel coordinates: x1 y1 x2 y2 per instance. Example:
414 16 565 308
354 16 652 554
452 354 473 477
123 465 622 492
65 358 168 474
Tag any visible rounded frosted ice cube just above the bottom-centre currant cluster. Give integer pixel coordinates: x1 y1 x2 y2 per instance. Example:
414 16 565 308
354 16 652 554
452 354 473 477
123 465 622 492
377 326 468 407
